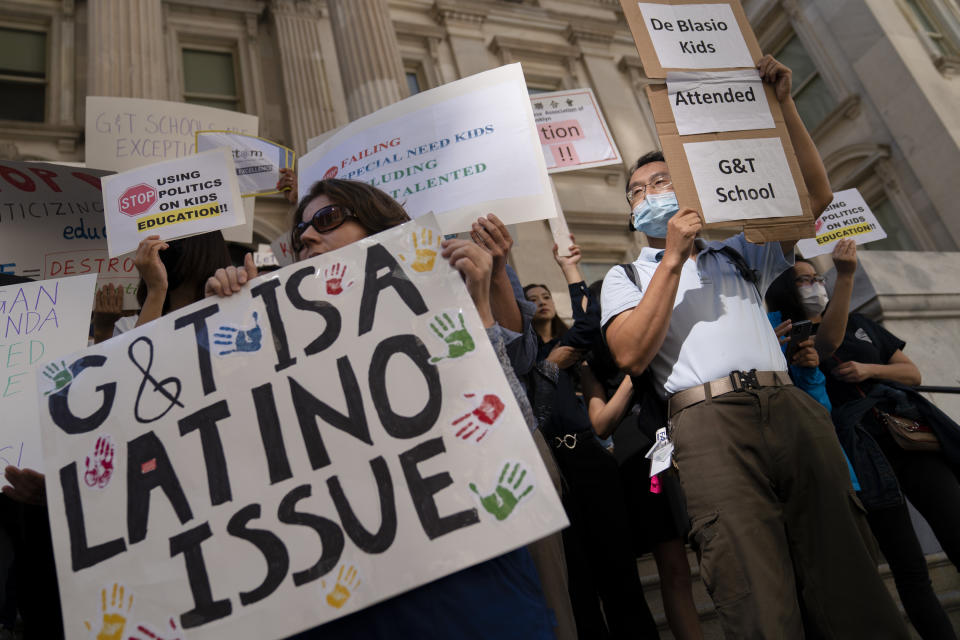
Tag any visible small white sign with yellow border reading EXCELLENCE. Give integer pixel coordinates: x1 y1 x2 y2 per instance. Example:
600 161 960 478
196 131 295 197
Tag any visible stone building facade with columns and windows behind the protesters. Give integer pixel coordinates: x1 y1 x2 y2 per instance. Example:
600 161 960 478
0 0 960 414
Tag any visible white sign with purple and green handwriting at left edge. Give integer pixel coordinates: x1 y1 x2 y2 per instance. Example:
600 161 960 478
0 274 97 472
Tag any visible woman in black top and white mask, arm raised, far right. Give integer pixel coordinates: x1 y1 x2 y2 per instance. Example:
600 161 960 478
766 240 960 640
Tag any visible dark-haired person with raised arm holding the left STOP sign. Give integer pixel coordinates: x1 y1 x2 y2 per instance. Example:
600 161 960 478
113 231 231 335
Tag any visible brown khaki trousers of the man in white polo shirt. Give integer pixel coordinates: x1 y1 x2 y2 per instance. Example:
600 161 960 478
672 386 910 640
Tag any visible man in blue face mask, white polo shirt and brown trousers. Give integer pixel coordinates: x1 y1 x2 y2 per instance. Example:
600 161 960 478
601 56 909 639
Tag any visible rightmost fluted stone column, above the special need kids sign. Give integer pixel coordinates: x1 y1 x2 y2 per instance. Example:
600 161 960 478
328 0 407 120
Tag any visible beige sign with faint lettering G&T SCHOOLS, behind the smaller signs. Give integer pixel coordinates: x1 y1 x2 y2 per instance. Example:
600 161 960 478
84 96 258 242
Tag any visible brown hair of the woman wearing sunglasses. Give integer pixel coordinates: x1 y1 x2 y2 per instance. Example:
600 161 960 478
291 178 410 252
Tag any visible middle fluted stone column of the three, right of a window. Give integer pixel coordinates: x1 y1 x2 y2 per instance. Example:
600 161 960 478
270 0 337 151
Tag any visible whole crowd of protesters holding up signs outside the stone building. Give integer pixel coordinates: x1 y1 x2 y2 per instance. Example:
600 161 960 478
0 56 960 640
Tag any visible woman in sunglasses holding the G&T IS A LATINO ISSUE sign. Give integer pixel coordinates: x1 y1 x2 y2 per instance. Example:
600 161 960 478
206 179 554 640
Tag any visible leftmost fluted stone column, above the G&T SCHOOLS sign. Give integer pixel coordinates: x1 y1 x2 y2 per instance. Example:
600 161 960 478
87 0 169 100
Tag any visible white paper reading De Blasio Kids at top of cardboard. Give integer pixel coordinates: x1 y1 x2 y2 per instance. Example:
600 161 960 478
638 2 753 69
